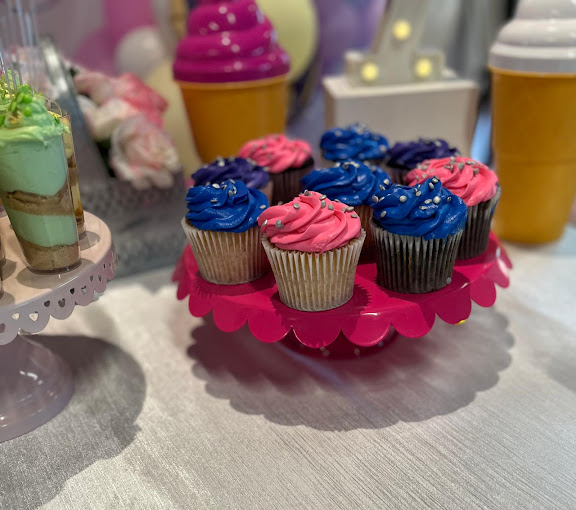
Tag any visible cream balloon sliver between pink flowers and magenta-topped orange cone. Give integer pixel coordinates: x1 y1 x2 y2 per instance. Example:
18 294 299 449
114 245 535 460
144 59 201 176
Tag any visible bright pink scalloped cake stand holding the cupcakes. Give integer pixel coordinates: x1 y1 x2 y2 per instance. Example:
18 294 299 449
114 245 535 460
172 234 512 355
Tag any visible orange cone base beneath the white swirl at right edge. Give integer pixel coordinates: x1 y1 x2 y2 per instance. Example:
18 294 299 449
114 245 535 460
491 68 576 243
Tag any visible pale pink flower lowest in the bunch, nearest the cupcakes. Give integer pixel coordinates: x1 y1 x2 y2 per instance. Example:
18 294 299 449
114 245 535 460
110 115 181 188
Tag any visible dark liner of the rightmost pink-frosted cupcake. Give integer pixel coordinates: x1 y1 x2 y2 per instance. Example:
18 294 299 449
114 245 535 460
457 186 502 259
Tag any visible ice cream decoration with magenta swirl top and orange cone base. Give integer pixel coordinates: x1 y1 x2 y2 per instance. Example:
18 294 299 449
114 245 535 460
173 0 290 163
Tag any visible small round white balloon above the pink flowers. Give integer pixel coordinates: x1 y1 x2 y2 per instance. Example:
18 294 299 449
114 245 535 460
115 27 166 78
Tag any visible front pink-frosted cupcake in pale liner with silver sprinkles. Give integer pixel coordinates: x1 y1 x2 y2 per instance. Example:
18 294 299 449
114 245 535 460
258 191 366 312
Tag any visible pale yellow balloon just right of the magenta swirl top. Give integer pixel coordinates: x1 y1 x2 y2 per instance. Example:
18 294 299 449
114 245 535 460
258 0 318 81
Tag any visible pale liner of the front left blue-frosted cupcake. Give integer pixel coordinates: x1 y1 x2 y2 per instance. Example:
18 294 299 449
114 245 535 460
182 218 269 285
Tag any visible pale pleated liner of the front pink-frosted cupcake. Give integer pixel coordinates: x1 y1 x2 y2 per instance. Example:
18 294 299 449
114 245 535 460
262 230 366 312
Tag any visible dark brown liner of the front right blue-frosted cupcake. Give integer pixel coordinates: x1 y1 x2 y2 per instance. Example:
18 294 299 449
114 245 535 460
370 220 463 294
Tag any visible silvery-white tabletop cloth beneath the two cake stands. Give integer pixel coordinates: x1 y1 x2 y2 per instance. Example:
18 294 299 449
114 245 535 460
0 229 576 510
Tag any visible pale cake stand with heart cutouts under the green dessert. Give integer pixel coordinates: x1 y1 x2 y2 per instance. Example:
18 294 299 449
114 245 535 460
0 213 116 442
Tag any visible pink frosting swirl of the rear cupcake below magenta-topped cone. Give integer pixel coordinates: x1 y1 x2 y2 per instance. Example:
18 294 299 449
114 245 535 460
238 135 312 174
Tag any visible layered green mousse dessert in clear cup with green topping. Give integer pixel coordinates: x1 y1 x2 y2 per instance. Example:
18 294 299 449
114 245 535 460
0 85 80 272
